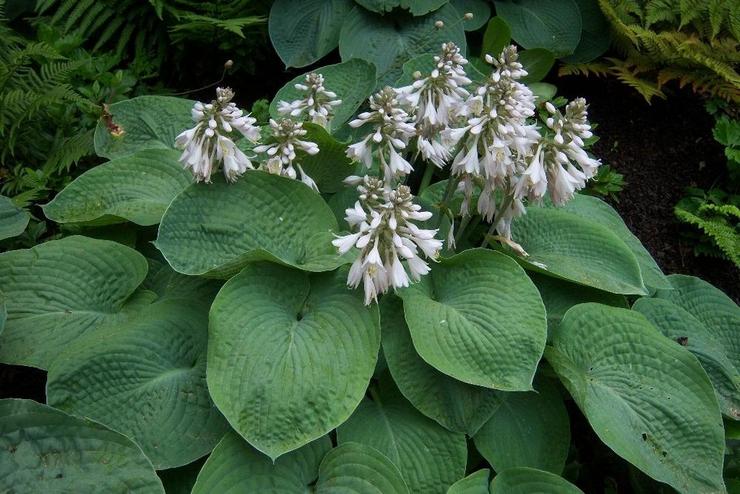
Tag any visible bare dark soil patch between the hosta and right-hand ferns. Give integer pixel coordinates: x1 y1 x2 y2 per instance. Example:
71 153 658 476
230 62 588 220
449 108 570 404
552 77 740 301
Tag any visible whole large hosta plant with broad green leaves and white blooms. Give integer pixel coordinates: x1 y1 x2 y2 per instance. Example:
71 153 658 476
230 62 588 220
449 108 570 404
0 43 740 494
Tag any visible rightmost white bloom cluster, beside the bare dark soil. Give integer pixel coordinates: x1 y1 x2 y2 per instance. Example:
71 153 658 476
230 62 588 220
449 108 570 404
522 98 601 206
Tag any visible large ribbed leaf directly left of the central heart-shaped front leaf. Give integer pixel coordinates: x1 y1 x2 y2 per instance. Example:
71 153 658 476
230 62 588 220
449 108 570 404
46 300 228 469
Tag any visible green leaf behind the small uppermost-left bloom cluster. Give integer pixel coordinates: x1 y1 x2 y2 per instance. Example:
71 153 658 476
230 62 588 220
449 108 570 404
270 58 375 131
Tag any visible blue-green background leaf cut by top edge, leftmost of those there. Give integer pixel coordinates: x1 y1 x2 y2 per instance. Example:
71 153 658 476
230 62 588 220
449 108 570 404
268 0 354 67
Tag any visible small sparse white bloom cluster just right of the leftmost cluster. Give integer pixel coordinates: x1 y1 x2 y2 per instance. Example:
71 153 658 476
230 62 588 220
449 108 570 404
254 118 319 192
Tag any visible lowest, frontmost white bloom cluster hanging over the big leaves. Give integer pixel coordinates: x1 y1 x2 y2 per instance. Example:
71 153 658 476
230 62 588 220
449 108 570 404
332 175 442 305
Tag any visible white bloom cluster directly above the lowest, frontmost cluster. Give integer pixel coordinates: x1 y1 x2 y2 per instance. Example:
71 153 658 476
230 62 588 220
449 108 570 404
347 87 416 184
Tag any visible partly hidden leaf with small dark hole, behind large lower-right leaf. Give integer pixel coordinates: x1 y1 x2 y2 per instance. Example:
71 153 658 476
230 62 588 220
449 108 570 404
632 298 740 420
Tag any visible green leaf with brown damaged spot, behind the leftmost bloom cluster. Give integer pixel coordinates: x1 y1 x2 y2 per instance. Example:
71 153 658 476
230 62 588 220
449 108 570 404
95 96 194 159
